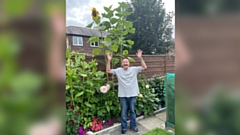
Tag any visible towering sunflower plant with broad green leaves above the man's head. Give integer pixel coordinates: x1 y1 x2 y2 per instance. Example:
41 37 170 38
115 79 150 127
87 2 135 73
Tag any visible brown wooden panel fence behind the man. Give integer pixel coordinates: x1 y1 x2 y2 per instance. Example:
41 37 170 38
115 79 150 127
86 55 175 78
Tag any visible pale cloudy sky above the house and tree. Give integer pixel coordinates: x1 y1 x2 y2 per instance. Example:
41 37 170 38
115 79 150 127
66 0 175 27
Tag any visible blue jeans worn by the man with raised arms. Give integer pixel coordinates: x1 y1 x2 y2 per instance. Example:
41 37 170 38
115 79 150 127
119 97 137 130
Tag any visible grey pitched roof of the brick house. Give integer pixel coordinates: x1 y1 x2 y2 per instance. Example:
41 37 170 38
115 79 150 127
66 26 107 37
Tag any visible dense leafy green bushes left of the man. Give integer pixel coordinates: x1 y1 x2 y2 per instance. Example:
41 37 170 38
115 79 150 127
66 50 120 134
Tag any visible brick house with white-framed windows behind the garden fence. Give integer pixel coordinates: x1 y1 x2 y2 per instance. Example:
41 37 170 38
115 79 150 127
66 26 107 55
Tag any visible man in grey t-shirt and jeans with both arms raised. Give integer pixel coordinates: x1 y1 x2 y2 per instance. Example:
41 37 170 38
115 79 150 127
106 50 147 135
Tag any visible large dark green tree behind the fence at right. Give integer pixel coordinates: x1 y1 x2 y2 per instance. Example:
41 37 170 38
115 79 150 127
126 0 173 54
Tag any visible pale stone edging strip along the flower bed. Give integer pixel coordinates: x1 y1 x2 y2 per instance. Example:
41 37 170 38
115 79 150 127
87 107 166 135
